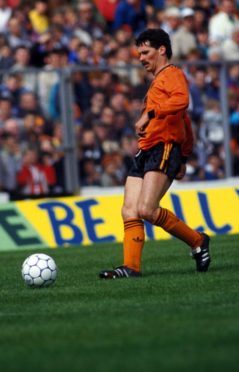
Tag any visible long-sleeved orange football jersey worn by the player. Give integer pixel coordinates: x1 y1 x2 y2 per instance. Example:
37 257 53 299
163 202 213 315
139 65 193 156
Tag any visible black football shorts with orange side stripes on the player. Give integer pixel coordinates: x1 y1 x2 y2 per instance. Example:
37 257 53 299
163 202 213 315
128 142 182 180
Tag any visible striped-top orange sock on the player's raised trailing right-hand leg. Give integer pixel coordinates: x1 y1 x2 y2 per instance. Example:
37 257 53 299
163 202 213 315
154 208 203 248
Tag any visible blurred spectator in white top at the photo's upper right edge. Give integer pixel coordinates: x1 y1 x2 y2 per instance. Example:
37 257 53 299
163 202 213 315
209 0 238 45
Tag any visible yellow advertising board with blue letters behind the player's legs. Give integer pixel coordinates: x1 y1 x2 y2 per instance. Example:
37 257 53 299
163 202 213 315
0 187 239 251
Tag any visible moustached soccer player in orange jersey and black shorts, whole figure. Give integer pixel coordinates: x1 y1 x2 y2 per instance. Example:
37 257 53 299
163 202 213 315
99 29 211 279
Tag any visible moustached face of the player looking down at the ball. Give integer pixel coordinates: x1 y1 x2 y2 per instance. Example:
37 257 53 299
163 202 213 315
137 42 165 74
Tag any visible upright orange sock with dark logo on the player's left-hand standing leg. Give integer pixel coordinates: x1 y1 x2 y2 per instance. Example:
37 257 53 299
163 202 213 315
124 218 145 271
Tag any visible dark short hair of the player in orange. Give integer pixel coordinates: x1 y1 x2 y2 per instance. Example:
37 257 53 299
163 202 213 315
135 28 172 59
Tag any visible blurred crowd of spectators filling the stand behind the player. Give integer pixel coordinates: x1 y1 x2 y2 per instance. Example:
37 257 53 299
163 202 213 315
0 0 239 198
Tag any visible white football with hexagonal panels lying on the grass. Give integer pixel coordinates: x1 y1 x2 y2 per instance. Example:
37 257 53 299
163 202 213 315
22 253 57 288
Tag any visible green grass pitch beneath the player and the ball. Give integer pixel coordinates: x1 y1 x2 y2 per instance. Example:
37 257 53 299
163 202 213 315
0 235 239 372
